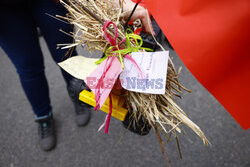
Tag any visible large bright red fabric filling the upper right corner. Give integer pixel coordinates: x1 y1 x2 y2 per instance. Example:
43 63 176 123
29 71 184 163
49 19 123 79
144 0 250 129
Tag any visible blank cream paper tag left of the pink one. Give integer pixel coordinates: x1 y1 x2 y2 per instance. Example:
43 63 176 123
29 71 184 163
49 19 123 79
58 56 99 80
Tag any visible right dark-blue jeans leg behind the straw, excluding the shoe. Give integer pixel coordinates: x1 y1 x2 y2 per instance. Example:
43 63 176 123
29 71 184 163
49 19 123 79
32 0 74 85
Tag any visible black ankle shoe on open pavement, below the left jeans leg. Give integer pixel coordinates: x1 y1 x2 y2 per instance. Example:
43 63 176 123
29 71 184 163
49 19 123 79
36 114 56 151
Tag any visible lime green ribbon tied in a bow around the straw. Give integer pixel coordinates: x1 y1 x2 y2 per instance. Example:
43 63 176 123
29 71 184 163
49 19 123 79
95 29 153 68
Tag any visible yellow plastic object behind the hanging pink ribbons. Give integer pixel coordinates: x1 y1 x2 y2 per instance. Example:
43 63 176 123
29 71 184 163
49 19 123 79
79 90 128 121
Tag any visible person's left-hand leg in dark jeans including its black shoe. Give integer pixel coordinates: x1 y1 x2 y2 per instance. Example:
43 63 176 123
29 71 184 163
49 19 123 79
0 5 56 151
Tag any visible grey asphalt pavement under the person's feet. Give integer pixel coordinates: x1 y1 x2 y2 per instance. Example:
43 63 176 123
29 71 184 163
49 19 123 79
0 38 250 167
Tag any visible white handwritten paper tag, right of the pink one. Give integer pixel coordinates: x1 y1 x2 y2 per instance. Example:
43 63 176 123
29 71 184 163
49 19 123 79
120 51 169 94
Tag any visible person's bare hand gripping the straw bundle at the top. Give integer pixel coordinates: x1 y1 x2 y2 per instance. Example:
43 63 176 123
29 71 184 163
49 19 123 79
115 0 154 34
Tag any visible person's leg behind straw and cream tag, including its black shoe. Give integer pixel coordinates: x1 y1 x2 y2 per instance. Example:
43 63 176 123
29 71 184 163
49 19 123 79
33 0 90 126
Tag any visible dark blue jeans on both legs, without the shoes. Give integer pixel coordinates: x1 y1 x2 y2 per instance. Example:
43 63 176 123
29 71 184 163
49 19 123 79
0 0 76 117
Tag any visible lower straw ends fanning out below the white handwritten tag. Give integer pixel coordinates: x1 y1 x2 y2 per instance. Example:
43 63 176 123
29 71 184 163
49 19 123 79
126 58 209 145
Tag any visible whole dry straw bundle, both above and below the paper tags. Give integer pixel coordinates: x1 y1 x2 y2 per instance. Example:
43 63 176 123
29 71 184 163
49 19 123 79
57 0 209 157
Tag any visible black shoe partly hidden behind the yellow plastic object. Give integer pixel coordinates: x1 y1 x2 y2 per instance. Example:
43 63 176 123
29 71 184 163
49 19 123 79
68 78 91 126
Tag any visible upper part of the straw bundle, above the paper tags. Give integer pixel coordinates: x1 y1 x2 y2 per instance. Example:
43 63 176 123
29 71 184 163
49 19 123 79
57 0 130 53
